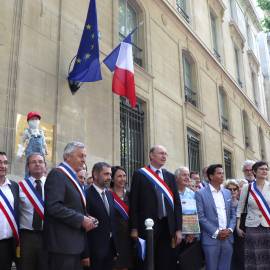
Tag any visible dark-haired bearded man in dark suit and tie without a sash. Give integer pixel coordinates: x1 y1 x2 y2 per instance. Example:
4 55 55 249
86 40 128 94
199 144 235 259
83 162 116 270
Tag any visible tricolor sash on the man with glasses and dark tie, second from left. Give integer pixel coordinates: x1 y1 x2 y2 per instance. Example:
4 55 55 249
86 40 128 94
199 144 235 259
19 178 44 220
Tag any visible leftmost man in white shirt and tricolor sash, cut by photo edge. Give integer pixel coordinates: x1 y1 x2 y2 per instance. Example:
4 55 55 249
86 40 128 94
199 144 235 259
0 152 19 270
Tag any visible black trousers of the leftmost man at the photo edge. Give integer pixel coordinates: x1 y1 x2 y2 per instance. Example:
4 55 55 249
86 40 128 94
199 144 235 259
0 238 15 270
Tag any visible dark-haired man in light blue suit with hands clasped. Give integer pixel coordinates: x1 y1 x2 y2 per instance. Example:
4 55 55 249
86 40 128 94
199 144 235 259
195 164 236 270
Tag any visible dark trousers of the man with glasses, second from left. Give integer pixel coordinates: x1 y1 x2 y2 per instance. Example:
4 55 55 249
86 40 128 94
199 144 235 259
20 230 48 270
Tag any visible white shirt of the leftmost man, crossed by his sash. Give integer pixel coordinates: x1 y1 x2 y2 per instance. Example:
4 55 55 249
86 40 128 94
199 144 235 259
0 178 14 240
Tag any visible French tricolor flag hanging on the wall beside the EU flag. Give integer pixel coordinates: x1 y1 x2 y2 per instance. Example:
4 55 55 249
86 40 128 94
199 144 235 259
103 31 136 108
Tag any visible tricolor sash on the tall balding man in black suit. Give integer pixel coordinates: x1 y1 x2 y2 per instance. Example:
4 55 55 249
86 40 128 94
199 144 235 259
139 167 174 208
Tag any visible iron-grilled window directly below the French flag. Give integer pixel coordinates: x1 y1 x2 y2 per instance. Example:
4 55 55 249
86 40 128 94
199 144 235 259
120 97 145 186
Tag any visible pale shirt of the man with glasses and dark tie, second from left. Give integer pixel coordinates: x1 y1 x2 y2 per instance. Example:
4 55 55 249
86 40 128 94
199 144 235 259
20 176 46 230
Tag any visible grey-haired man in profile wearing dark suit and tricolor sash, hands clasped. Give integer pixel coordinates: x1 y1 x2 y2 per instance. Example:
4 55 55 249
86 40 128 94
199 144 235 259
44 142 95 270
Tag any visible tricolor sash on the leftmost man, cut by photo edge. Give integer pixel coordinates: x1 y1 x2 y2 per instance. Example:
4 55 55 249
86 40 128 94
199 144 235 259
0 189 20 246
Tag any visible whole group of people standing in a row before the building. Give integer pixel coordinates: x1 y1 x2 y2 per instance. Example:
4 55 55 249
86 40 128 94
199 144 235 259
0 142 270 270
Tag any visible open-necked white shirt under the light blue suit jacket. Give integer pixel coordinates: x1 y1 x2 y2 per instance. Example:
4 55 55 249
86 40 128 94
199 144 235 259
209 184 227 230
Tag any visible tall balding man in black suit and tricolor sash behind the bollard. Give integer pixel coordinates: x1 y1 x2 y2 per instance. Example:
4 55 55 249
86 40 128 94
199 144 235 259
130 145 182 270
